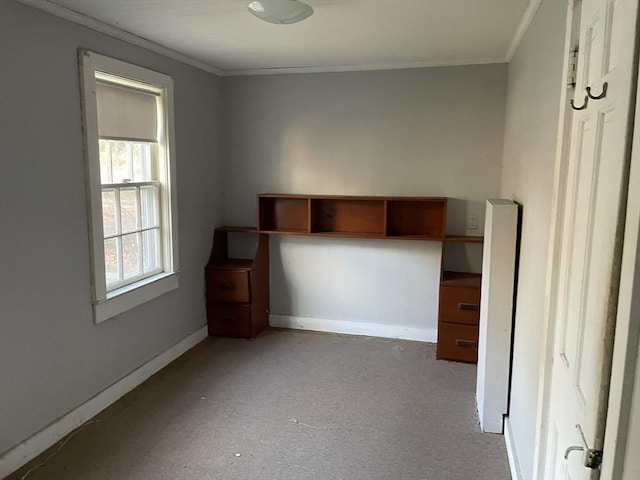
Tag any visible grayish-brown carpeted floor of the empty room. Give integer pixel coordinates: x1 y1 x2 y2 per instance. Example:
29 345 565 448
9 329 511 480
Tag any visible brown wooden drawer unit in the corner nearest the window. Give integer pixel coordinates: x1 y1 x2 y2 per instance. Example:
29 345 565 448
205 227 269 338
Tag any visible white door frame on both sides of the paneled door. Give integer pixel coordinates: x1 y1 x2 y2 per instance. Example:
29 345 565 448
533 0 640 480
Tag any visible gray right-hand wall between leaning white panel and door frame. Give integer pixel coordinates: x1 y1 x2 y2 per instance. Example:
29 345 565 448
502 0 567 480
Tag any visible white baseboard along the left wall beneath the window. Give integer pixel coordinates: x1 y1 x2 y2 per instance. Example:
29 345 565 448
0 326 207 479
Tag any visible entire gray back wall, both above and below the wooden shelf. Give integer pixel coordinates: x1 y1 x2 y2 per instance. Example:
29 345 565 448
223 64 507 338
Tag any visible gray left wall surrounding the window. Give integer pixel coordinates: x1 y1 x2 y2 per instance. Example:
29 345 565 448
0 0 221 452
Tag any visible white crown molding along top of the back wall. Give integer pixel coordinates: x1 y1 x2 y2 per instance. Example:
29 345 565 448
222 57 506 77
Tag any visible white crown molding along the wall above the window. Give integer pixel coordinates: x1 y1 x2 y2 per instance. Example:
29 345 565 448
16 0 224 76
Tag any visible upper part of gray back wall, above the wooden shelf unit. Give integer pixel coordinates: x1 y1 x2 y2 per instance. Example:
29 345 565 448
223 64 507 233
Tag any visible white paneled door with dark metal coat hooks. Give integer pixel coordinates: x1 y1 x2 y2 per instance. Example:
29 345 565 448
545 0 638 480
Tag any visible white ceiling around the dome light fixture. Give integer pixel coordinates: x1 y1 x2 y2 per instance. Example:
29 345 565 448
20 0 539 75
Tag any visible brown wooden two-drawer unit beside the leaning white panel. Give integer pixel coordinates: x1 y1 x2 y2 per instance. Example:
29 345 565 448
436 272 480 363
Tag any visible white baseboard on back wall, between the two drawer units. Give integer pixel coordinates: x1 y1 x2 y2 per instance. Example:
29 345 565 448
269 315 438 343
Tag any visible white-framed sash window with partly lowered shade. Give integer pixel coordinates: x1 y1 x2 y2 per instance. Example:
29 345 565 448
80 51 178 322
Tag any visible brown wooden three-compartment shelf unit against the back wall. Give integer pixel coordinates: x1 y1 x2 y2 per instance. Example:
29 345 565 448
258 193 447 241
